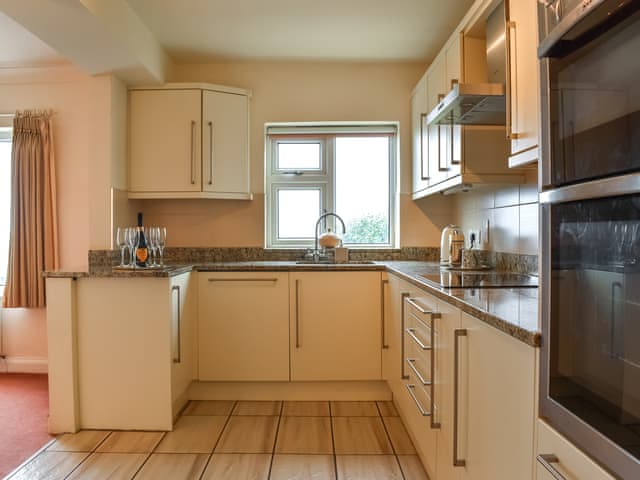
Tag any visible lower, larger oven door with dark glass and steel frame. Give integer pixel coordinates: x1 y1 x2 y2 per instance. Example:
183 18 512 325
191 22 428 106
539 174 640 479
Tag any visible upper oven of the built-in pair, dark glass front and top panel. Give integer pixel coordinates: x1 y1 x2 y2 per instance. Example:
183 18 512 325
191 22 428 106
539 0 640 188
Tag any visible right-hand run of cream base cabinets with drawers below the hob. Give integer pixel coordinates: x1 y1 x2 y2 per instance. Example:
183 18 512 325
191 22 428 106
385 275 537 480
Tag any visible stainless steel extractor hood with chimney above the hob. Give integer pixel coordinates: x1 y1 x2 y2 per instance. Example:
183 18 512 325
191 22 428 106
427 3 506 125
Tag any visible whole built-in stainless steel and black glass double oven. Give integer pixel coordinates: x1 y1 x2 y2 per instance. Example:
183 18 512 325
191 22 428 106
538 0 640 479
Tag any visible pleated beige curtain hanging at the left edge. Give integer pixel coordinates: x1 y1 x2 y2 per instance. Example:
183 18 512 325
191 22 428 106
3 112 58 308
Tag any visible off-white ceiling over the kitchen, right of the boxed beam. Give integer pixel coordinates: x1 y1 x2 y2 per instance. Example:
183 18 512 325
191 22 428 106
127 0 473 63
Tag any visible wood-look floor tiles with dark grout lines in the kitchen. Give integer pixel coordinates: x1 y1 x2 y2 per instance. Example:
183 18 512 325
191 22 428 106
8 401 427 480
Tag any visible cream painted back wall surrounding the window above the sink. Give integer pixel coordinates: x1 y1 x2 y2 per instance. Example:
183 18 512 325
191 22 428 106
135 62 449 246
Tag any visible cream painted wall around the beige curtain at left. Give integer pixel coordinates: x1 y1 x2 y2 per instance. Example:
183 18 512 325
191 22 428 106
0 66 126 359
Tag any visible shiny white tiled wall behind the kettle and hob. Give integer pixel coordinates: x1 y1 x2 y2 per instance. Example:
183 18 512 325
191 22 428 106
454 170 538 255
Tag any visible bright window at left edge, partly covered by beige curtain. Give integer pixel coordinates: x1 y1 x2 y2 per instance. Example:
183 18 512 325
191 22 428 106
0 127 12 296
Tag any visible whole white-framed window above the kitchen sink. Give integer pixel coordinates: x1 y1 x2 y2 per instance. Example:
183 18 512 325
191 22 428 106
265 124 397 248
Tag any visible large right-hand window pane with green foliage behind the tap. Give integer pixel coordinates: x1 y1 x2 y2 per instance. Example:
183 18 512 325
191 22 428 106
336 137 390 244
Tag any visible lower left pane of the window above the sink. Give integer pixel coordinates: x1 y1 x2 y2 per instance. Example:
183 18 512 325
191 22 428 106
277 189 320 240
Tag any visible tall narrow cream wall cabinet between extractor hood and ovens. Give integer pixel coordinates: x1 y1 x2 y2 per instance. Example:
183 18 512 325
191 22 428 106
505 0 540 167
